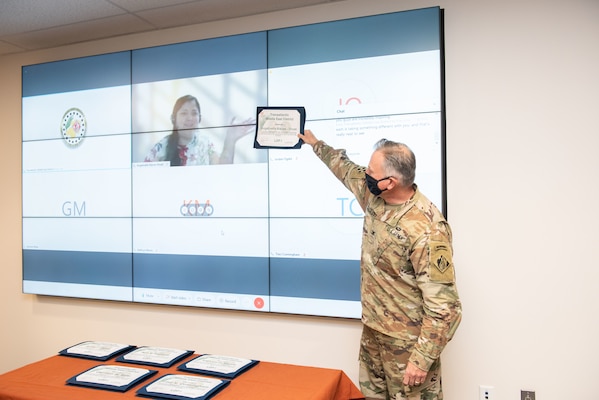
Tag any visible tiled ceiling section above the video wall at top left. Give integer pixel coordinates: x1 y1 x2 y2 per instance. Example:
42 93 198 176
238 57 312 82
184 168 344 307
0 0 339 56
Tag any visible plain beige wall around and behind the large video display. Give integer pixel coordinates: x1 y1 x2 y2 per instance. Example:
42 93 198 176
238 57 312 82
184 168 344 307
0 0 599 400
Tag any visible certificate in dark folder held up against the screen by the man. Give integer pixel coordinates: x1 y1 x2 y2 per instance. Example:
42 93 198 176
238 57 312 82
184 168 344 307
254 107 306 149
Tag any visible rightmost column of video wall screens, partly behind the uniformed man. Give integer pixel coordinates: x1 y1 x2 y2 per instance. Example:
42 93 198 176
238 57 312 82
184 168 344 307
269 10 443 318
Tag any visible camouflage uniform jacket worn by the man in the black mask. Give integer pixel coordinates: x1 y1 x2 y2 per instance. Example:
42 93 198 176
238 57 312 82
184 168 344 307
313 141 462 371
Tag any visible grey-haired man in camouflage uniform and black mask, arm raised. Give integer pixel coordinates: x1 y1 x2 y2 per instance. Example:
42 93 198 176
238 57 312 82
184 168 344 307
298 130 462 400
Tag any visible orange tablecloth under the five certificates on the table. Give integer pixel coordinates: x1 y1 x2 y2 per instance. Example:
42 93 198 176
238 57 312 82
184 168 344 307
0 355 364 400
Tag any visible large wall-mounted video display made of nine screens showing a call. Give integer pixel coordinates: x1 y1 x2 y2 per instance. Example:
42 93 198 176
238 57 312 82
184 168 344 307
22 8 445 318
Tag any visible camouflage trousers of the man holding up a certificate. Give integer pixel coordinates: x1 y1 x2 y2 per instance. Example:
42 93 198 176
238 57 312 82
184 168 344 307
359 326 443 400
